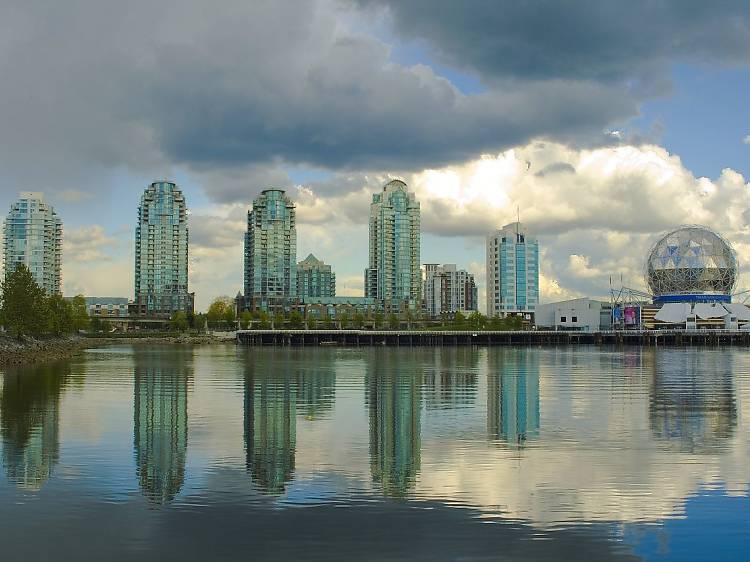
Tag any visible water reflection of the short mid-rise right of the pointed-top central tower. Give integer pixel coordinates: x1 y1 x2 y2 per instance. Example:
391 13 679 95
422 347 479 410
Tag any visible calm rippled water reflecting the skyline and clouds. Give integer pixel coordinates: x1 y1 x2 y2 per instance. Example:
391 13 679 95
0 346 750 562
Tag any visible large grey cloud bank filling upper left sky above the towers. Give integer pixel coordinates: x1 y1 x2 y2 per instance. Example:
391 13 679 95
0 0 638 202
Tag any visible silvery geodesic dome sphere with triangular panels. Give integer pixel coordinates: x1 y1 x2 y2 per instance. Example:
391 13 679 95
646 226 737 297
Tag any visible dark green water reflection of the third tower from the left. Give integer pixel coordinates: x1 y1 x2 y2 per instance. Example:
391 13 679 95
245 351 297 495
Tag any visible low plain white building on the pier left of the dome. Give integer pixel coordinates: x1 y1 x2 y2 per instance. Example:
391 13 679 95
535 298 612 332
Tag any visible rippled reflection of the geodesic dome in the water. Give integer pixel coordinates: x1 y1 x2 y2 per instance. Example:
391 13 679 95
649 349 737 453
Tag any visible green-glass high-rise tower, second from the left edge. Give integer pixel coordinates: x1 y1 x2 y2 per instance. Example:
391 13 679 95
132 181 194 316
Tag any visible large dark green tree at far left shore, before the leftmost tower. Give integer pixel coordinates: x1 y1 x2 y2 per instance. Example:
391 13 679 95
0 264 47 336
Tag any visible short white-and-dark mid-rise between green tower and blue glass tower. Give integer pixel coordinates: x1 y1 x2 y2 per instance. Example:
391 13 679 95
423 263 477 316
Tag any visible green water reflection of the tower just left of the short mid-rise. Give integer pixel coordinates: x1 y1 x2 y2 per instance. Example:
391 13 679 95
365 349 426 498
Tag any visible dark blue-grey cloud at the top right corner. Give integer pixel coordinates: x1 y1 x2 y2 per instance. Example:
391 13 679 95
357 0 750 81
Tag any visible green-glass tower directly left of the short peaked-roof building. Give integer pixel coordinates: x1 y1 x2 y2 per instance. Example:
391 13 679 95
245 189 297 310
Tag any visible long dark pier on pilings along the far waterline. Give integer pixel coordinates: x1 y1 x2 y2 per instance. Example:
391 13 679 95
237 330 750 347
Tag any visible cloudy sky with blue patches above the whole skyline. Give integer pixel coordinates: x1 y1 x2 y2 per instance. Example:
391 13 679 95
0 0 750 309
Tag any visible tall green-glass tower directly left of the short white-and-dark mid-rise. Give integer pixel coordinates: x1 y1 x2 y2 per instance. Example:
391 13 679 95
365 180 422 311
